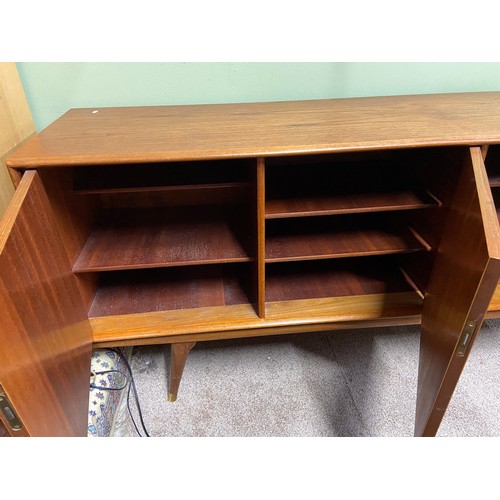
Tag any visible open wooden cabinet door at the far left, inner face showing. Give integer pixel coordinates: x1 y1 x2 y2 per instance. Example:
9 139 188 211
0 171 91 436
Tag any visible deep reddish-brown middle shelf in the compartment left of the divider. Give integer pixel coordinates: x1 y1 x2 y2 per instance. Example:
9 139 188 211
73 207 252 273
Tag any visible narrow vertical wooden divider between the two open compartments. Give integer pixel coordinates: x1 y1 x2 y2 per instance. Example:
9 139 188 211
256 158 266 318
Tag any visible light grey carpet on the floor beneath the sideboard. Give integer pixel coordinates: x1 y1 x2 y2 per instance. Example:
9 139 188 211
112 320 500 437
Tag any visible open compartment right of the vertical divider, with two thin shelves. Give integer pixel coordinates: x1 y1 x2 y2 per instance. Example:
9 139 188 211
263 151 442 311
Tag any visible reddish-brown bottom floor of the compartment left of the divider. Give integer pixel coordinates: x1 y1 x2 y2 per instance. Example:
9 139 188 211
89 264 249 317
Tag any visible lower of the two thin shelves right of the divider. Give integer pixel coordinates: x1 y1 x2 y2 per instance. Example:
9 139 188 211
265 217 430 262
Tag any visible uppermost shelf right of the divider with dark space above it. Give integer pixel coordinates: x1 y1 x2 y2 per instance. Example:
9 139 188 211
265 153 440 219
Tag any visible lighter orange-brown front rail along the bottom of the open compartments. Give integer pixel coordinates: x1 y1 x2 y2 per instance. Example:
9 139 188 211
90 292 422 346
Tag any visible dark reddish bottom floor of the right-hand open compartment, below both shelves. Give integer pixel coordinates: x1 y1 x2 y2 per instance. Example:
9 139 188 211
266 257 415 302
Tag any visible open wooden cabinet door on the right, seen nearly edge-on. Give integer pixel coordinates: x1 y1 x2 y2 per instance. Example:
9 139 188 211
415 147 500 436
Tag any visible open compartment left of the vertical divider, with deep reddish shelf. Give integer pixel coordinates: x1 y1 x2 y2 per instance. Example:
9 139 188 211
73 160 256 317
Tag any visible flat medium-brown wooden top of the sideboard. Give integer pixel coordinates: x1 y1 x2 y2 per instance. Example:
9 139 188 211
7 92 500 169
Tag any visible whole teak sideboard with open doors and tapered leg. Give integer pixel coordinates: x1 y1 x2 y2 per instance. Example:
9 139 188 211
0 92 500 436
